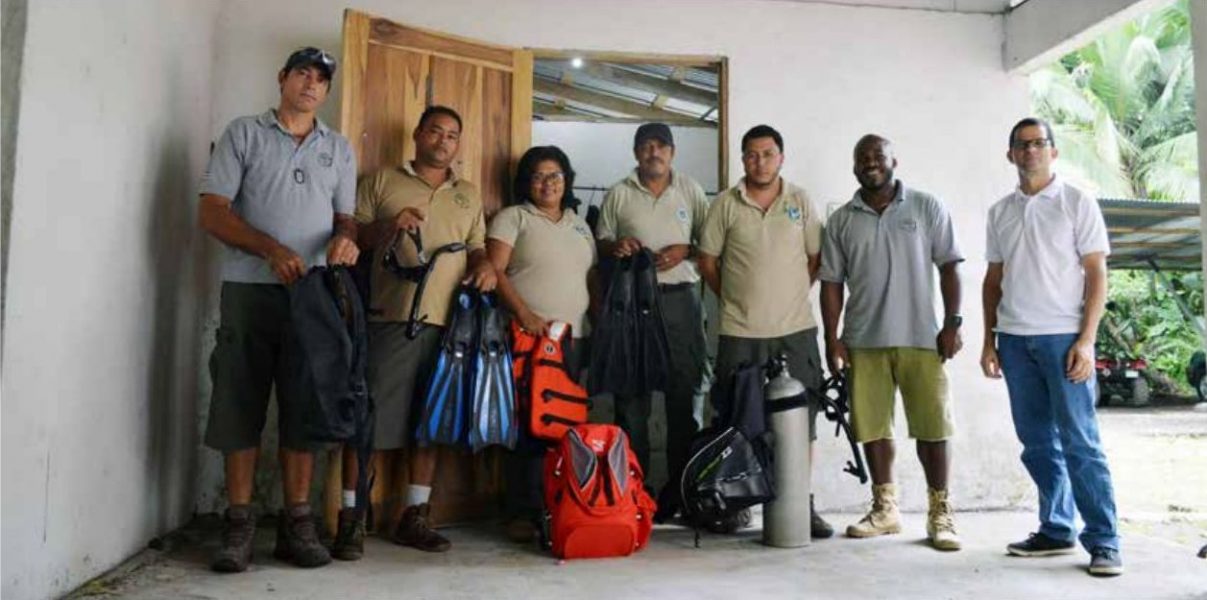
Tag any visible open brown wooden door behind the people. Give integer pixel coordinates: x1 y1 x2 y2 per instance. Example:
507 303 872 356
326 10 532 530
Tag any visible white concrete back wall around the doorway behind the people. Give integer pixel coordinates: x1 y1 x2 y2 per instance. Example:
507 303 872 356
198 0 1032 509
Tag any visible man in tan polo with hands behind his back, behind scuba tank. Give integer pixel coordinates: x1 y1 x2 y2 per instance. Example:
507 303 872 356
699 126 834 537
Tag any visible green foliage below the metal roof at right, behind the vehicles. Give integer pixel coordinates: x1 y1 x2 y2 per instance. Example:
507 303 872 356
1098 270 1203 394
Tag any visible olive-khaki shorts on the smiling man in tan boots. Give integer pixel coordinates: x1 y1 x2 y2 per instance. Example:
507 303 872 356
847 348 955 442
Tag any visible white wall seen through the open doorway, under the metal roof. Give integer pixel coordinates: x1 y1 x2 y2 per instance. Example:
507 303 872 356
532 121 719 205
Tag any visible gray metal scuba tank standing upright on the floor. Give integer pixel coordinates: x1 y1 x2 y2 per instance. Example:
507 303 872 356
763 355 811 548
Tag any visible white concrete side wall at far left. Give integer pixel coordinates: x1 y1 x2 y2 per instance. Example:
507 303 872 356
0 0 218 599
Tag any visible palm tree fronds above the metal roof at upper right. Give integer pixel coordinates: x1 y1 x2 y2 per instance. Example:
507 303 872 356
1031 0 1199 202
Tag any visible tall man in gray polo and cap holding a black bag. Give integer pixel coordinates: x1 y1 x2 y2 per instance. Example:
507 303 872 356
198 48 358 572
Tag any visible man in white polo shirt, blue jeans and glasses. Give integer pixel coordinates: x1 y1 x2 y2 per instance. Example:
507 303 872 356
981 118 1123 576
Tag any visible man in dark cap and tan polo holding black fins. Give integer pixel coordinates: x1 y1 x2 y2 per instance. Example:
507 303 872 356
596 123 709 522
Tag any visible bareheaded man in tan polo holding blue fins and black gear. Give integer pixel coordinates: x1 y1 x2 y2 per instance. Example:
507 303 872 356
347 106 496 552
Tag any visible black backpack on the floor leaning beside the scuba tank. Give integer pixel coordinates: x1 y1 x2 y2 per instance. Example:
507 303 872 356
680 365 775 546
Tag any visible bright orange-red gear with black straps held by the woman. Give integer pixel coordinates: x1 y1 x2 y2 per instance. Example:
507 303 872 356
512 321 588 442
